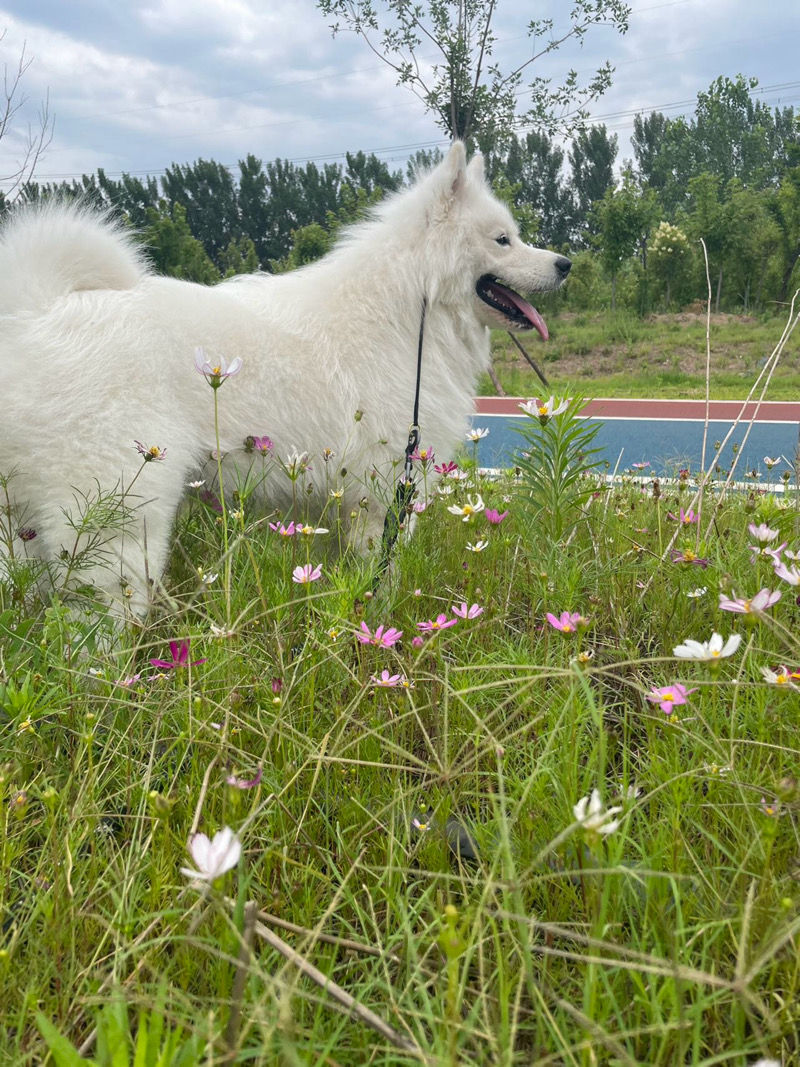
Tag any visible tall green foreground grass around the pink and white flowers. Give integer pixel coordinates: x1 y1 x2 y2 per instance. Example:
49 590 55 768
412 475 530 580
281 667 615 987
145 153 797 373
0 407 800 1067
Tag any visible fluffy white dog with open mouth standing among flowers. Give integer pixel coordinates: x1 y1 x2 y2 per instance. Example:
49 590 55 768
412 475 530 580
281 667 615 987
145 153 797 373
0 143 570 615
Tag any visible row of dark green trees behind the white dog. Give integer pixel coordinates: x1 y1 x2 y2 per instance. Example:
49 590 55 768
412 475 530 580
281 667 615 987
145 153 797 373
6 76 800 313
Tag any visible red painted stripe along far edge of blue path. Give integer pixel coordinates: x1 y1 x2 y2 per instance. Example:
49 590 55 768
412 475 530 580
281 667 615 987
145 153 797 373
475 397 800 423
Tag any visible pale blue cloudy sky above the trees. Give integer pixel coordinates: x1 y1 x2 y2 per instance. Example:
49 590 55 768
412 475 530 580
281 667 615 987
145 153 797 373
0 0 800 192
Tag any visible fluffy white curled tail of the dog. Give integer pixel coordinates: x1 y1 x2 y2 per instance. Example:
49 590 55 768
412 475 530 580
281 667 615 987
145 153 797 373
0 202 148 315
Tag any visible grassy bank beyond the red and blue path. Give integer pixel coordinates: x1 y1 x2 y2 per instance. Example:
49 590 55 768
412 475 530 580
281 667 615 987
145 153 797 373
481 312 800 400
